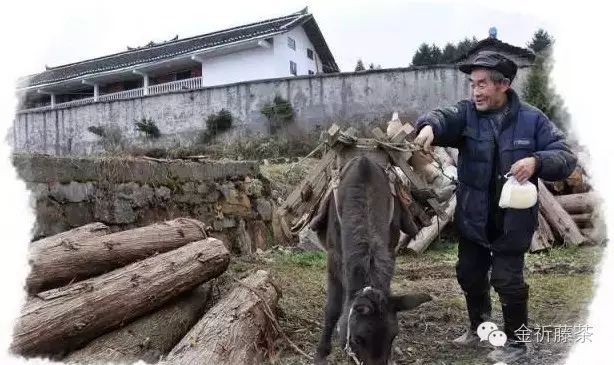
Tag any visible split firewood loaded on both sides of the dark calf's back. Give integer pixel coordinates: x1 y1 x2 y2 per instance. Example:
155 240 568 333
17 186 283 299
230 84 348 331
276 113 457 252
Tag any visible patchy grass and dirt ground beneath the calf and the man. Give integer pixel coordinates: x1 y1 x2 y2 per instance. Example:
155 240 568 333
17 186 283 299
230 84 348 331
219 242 603 365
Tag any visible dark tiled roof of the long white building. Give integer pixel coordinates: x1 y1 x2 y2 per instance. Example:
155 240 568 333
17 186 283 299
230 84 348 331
19 9 339 87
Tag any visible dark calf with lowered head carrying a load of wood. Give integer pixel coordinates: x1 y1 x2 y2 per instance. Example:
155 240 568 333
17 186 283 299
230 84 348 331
311 156 430 365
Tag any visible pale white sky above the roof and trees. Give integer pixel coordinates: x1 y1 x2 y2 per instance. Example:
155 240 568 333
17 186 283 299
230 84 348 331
22 0 556 74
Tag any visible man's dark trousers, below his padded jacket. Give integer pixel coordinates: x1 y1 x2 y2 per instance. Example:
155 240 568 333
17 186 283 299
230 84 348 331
456 233 529 341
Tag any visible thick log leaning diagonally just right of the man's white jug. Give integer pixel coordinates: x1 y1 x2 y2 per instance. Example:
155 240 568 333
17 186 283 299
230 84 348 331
538 180 587 246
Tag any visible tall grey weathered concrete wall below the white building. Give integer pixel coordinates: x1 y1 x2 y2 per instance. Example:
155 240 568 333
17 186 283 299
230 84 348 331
9 66 529 155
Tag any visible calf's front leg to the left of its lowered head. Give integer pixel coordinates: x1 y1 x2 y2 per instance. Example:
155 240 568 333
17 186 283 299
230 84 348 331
315 272 343 364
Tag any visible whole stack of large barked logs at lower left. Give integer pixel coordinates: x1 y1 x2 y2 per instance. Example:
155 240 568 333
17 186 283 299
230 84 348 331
11 218 281 364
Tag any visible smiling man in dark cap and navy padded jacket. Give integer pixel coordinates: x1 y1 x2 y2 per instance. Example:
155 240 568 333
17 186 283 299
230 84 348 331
415 51 576 363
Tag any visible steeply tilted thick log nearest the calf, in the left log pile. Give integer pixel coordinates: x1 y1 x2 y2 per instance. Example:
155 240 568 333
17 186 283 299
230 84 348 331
161 270 281 365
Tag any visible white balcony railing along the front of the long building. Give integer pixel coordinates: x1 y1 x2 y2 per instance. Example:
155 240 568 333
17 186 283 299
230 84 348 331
18 77 203 113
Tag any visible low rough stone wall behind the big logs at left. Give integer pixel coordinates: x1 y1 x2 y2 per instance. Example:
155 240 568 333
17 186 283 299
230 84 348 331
13 155 274 253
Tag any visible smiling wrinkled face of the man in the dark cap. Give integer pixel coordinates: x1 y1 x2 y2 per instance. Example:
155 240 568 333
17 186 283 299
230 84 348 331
469 68 509 111
